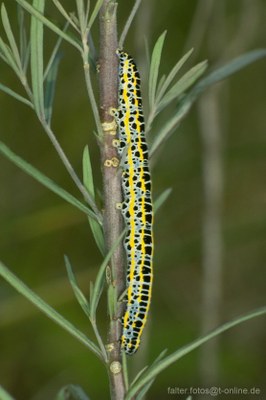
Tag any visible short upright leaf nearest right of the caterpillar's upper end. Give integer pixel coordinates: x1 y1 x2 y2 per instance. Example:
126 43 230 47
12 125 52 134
149 31 166 108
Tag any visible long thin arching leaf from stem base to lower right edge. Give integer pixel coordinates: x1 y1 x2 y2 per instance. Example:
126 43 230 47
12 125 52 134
125 307 266 400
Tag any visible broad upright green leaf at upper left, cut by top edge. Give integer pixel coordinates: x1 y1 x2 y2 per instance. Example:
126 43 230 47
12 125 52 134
30 0 45 120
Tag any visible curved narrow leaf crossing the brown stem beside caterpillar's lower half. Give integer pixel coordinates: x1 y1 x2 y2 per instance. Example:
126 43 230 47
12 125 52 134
90 229 126 321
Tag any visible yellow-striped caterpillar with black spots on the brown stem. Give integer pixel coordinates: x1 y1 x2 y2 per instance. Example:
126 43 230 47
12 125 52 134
113 50 153 354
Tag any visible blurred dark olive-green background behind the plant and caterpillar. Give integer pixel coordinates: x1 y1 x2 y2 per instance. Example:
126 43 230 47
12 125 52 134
0 0 266 400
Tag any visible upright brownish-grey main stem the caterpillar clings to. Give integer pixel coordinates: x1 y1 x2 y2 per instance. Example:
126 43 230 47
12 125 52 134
99 0 125 400
